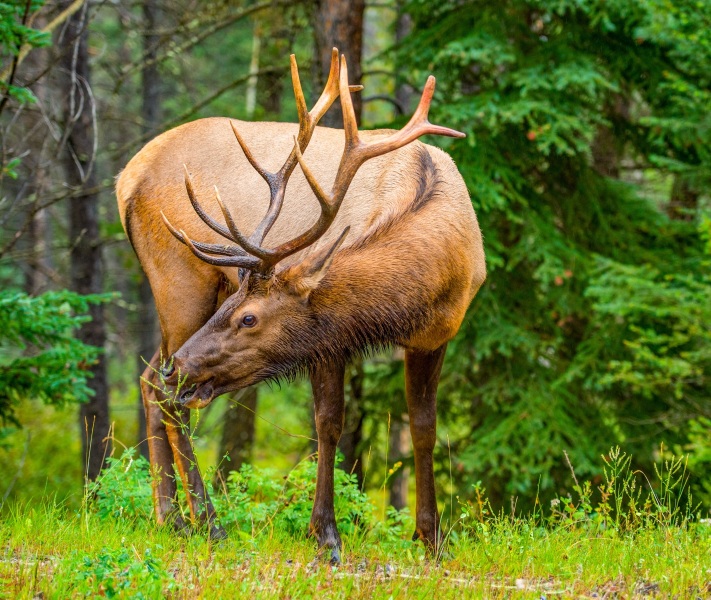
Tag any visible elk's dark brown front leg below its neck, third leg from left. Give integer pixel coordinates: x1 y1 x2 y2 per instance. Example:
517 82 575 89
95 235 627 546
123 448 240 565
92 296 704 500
309 364 345 564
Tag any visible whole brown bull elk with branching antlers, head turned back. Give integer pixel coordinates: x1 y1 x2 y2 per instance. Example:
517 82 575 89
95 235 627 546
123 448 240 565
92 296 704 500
116 48 486 562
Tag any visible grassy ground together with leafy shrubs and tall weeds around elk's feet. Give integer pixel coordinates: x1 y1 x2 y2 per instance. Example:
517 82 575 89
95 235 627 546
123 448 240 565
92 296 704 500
0 450 711 600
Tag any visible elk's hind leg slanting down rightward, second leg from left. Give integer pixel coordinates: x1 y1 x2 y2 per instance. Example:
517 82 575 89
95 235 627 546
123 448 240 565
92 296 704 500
164 404 227 540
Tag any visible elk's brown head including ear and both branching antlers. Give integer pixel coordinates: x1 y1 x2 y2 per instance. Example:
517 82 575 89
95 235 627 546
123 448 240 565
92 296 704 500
161 48 463 408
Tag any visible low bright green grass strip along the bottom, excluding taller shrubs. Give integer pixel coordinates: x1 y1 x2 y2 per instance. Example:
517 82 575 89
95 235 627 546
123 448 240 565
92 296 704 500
0 501 711 600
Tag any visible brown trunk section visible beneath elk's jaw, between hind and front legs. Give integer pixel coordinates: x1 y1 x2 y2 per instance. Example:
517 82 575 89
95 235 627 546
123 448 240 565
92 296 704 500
218 386 257 481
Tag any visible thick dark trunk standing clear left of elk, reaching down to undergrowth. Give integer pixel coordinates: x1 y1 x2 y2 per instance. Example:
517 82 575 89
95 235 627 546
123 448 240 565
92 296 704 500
57 2 111 480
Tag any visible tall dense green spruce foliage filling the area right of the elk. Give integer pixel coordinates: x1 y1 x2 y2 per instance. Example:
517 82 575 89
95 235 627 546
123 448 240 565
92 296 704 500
384 0 711 500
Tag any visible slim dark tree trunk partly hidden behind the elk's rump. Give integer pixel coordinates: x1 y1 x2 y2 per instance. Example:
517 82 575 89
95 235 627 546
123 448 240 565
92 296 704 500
138 0 161 459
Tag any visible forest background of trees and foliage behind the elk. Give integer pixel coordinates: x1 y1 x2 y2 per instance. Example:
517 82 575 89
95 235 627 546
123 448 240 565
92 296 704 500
0 0 711 517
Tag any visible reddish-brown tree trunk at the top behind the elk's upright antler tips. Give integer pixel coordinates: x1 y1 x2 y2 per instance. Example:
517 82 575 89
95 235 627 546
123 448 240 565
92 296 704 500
314 0 365 127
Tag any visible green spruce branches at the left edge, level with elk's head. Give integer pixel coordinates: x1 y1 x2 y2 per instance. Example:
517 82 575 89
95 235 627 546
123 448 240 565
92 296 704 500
0 291 109 424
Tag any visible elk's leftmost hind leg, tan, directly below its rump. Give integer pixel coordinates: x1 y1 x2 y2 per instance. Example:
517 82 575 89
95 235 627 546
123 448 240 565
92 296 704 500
140 352 187 531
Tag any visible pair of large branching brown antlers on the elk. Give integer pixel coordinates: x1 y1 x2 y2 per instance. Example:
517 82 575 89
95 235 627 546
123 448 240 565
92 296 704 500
161 48 464 273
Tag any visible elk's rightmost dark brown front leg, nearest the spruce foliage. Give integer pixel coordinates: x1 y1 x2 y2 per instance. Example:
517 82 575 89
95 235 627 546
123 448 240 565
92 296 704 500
405 344 446 553
